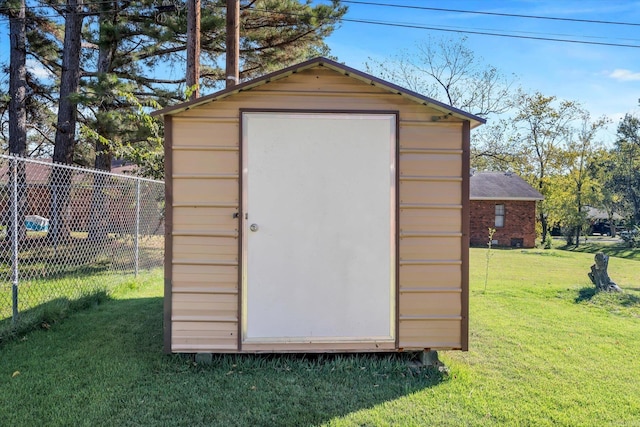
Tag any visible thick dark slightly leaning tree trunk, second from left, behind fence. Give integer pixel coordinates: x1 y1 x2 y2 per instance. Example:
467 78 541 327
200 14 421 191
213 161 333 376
49 0 83 240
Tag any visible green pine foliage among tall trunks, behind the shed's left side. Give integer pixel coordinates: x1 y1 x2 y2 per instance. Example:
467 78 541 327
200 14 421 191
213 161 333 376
0 0 346 173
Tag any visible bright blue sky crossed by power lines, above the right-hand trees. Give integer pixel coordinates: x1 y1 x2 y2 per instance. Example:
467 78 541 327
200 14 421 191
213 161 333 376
315 0 640 142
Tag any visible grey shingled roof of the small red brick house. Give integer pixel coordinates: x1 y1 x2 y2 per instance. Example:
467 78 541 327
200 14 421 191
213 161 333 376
469 172 544 201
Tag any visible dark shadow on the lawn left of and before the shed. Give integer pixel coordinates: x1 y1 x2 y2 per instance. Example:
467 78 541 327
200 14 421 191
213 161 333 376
0 292 449 426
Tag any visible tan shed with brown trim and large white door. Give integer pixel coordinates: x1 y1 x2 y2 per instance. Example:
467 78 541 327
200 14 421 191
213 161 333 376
155 58 484 353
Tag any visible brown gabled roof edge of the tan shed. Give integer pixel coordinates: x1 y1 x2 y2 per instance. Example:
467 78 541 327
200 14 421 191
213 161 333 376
152 57 486 128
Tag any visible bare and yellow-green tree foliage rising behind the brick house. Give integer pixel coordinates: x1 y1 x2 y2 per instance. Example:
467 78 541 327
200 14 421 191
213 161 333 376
367 38 640 244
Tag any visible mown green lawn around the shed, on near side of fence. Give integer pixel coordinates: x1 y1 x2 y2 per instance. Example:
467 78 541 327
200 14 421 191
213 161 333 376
0 249 640 426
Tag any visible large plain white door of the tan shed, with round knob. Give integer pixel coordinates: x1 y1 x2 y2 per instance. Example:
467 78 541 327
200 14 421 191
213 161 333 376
242 112 396 347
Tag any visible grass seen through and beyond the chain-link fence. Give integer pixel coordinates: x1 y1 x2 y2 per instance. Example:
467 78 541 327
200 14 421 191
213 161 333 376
0 231 163 342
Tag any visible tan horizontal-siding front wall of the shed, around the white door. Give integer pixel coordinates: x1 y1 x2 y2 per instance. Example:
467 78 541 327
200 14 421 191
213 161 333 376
165 67 469 352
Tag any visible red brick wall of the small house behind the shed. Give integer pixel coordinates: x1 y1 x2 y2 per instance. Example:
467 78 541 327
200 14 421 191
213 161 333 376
470 200 536 248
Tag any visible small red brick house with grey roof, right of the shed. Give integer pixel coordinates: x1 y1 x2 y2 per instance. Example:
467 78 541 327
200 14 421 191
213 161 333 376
469 171 544 248
